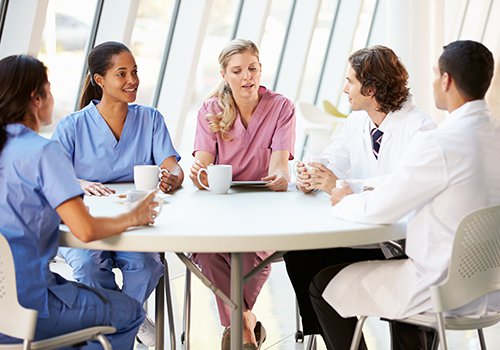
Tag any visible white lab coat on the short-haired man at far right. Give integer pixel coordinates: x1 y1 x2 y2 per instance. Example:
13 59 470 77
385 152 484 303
323 100 500 318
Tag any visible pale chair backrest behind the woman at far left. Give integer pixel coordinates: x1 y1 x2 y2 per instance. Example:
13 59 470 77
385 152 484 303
0 233 38 340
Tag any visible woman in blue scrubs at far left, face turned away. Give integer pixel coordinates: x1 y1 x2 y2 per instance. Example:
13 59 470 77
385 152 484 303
0 55 161 349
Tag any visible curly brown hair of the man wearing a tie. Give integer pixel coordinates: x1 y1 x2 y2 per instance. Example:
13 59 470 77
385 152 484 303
349 45 410 113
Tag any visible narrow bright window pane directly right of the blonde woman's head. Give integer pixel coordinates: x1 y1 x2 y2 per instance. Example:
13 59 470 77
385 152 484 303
259 0 292 88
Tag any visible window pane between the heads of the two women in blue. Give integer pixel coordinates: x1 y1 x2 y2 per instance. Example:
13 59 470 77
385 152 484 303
38 0 97 132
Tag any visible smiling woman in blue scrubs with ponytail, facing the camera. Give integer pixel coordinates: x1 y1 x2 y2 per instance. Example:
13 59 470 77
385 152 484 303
52 42 184 346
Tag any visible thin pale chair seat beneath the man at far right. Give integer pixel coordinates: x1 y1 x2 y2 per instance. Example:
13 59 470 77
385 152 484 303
398 312 500 330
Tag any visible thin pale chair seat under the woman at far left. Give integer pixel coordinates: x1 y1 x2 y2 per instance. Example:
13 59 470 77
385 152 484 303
0 326 116 350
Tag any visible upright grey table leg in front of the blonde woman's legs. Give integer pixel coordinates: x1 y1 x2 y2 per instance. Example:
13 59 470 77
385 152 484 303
231 253 243 350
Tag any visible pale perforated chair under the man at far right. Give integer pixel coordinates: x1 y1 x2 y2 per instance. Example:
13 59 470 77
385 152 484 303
351 206 500 350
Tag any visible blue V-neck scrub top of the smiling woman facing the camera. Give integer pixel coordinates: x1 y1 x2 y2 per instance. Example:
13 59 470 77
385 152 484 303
52 100 180 183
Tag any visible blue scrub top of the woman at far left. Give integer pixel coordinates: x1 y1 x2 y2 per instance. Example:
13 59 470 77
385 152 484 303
0 124 83 317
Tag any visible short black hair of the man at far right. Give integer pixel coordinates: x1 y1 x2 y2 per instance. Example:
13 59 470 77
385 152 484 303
438 40 495 100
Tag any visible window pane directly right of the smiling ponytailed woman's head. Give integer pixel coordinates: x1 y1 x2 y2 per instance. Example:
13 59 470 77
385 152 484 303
130 0 175 105
